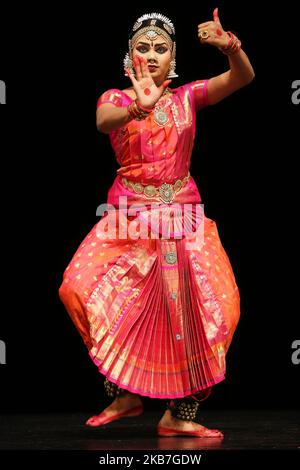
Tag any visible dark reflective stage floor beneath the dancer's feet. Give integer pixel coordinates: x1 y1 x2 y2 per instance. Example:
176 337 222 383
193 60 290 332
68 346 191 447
0 410 300 451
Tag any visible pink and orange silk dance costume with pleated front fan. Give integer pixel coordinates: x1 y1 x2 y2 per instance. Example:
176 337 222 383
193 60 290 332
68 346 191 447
59 80 240 399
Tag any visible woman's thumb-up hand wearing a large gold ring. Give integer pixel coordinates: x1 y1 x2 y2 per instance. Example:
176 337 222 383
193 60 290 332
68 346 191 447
198 8 230 48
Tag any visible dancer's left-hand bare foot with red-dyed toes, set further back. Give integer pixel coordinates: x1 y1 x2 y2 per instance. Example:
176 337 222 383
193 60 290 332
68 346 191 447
85 392 143 426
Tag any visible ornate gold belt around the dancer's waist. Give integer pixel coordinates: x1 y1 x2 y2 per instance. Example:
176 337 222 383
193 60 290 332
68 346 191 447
122 172 190 202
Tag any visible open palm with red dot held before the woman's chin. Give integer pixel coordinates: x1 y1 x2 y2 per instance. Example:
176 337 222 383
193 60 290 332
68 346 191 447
126 55 171 109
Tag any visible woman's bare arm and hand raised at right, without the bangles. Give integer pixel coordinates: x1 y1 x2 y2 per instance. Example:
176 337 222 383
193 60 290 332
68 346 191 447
198 8 255 105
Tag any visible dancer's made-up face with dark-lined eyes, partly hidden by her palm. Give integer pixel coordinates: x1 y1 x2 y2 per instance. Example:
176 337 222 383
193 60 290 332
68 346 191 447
132 35 172 83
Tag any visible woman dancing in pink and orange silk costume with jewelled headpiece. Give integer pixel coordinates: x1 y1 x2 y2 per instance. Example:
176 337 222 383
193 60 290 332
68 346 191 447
59 9 254 437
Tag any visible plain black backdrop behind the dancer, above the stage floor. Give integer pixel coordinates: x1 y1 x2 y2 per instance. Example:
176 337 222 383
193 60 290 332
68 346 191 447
0 0 300 412
